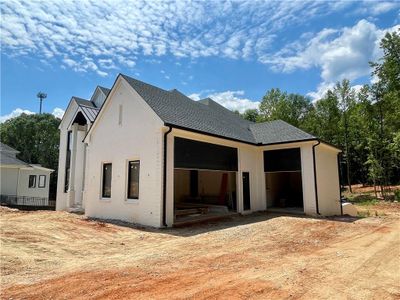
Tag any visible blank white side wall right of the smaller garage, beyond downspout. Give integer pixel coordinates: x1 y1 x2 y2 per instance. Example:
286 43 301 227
315 144 341 216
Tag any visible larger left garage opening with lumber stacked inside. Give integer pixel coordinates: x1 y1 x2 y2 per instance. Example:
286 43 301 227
174 137 237 224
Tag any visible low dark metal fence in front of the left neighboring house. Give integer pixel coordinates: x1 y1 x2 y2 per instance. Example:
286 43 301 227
0 195 56 209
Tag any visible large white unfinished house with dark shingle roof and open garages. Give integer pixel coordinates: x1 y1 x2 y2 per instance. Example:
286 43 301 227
57 74 341 227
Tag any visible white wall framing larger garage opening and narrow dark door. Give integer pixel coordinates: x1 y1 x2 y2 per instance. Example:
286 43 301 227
166 129 266 226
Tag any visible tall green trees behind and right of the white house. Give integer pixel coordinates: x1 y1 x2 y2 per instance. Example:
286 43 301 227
236 31 400 198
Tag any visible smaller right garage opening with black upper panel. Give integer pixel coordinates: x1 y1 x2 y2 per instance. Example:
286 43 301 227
264 148 304 213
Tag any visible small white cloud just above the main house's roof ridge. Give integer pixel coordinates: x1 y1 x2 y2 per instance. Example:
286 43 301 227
188 91 260 113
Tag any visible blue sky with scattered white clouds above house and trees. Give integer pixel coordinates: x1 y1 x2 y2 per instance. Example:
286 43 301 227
0 0 400 122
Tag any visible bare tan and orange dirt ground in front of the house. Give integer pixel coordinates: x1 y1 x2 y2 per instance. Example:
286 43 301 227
0 203 400 299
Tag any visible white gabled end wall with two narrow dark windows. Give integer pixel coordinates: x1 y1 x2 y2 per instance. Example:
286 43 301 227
84 78 163 227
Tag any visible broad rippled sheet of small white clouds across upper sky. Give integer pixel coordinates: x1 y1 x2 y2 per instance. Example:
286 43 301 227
0 0 362 76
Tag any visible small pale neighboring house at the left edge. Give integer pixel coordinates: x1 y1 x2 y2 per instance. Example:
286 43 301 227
0 143 54 206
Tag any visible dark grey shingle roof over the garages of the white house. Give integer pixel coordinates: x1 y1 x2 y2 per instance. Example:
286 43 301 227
121 74 316 145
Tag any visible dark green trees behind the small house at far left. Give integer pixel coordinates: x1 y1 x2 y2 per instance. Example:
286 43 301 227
0 114 60 197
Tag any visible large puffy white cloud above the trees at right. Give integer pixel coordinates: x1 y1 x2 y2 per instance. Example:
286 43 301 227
260 20 400 99
